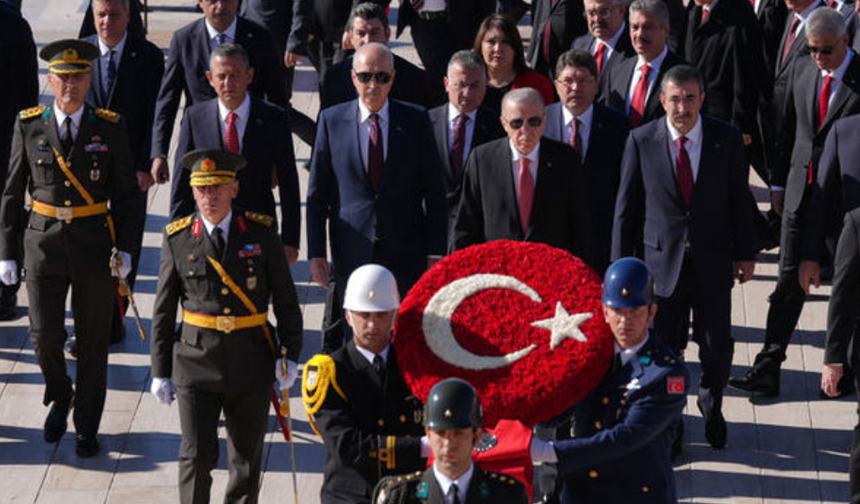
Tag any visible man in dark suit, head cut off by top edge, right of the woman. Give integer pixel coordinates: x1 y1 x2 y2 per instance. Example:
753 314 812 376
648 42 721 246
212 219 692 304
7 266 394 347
526 0 592 79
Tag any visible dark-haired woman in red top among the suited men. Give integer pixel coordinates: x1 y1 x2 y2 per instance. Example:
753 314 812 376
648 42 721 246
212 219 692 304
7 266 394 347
472 14 555 112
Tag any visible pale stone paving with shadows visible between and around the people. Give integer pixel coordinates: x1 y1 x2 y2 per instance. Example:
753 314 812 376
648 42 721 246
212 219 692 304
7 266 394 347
0 0 855 504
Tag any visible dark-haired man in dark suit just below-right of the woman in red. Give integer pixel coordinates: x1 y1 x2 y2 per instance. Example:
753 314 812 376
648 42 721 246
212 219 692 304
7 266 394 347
544 50 630 275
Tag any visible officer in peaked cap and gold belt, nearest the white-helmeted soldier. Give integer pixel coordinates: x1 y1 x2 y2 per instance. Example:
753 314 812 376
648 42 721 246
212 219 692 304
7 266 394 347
150 150 302 504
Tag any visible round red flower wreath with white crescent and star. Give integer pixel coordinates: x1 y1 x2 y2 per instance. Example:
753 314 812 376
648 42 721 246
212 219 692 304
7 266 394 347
393 240 613 427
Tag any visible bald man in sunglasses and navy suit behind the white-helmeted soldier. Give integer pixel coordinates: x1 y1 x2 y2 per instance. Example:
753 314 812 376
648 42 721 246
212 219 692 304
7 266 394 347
307 42 447 350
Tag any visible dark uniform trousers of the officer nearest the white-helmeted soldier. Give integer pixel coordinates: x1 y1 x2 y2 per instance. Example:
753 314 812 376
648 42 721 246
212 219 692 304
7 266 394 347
176 387 269 504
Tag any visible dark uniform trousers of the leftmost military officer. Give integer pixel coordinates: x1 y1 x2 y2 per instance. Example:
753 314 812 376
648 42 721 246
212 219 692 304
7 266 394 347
27 269 115 436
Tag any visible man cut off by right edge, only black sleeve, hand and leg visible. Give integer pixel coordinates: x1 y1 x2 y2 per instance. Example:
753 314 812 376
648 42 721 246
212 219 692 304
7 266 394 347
821 209 860 504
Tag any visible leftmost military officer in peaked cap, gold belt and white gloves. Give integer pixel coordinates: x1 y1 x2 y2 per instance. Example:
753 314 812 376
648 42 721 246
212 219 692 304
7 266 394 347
0 40 137 457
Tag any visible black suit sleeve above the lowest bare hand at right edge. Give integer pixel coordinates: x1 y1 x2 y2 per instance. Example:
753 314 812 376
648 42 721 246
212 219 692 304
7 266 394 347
824 210 860 364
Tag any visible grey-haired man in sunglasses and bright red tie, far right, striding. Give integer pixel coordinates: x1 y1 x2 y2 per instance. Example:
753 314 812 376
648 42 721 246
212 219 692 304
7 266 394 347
731 9 860 395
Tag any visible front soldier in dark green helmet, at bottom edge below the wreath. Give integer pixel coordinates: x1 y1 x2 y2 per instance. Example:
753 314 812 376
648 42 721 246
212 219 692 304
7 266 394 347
373 378 529 504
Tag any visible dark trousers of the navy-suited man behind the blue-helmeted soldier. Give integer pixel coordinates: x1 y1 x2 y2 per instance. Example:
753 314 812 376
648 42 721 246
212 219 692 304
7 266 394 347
654 253 735 414
